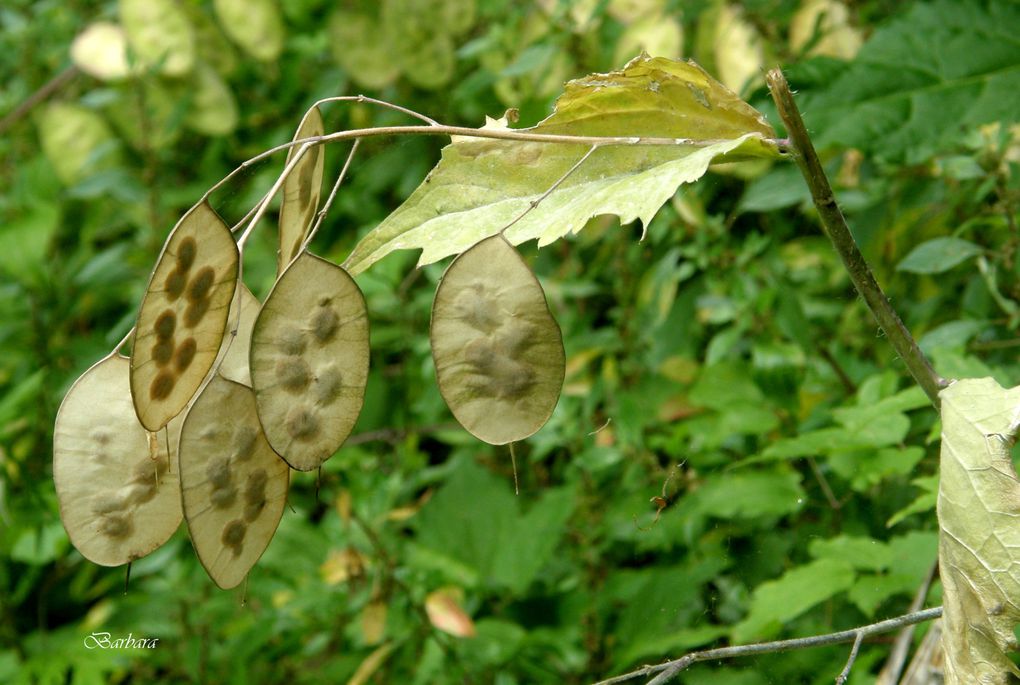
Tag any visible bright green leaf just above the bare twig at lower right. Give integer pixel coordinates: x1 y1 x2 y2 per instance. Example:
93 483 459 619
731 559 855 643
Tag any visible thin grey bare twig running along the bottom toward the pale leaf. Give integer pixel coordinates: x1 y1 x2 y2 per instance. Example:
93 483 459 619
595 607 942 685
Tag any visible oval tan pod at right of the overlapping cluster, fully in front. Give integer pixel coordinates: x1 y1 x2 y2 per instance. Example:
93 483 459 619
251 252 368 471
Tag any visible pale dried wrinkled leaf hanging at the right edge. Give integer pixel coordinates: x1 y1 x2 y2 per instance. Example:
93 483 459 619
938 378 1020 685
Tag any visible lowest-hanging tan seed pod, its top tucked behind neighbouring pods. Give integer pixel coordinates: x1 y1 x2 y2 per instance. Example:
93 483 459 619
180 376 290 589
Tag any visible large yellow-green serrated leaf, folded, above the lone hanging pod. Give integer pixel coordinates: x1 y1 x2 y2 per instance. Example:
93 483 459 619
345 56 778 274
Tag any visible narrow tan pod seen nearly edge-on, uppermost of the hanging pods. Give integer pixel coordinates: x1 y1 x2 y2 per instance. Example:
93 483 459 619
276 107 325 274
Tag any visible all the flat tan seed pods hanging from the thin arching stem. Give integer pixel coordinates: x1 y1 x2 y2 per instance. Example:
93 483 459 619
53 109 564 588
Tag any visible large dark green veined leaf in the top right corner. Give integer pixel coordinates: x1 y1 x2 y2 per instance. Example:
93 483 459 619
795 0 1020 162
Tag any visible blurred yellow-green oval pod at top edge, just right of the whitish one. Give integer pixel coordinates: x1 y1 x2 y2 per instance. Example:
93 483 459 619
119 0 195 76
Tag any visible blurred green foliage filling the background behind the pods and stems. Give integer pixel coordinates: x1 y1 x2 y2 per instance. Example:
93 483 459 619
0 0 1020 685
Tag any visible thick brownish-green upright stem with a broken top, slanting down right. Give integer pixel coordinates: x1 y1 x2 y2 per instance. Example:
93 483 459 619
765 69 947 409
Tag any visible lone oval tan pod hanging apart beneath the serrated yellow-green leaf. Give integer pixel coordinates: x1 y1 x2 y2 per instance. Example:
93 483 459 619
431 235 565 444
